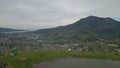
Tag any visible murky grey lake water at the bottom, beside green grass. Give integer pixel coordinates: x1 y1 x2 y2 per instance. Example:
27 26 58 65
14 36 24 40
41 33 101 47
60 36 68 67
34 58 120 68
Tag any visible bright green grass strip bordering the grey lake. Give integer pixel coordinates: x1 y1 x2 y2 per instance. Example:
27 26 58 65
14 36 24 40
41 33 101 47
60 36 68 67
0 50 120 68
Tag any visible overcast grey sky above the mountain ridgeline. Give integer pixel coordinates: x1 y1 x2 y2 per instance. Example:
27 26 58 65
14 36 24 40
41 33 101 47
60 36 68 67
0 0 120 30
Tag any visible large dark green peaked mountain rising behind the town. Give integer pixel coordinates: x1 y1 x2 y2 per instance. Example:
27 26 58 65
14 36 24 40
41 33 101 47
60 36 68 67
35 16 120 42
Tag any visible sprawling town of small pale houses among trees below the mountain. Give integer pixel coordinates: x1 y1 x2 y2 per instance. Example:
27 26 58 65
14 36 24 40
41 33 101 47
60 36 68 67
0 33 120 56
